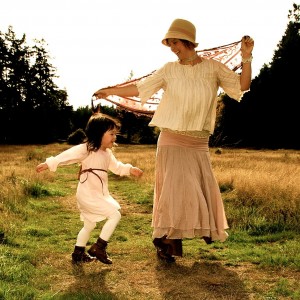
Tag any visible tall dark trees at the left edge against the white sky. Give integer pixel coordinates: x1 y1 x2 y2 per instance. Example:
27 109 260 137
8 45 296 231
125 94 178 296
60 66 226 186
0 26 72 144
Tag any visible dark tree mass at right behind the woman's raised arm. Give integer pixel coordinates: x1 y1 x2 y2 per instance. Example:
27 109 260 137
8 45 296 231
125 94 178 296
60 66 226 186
212 4 300 149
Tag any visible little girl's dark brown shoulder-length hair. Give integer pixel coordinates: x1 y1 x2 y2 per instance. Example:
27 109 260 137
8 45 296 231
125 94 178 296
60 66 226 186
85 113 121 151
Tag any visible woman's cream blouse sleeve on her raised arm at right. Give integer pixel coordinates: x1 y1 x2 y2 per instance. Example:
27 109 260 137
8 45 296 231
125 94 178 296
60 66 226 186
218 63 245 101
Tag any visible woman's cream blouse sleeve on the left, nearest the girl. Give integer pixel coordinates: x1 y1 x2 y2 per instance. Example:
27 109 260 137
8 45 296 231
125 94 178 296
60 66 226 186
136 66 165 104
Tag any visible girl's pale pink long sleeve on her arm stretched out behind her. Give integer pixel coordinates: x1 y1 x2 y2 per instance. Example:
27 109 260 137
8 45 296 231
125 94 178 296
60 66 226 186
46 144 88 172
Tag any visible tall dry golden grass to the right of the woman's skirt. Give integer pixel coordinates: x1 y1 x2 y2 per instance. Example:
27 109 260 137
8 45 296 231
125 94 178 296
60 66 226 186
212 149 300 205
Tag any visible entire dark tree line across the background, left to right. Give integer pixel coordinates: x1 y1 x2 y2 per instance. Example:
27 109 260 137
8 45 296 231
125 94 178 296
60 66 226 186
0 4 300 149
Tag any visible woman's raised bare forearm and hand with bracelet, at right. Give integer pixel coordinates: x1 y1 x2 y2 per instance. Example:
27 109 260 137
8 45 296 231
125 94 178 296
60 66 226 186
240 36 254 91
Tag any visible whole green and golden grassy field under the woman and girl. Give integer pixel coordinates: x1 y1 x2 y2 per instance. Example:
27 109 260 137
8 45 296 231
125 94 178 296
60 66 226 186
0 144 300 300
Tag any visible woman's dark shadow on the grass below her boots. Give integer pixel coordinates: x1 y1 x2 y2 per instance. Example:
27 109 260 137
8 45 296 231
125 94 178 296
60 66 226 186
156 262 250 300
